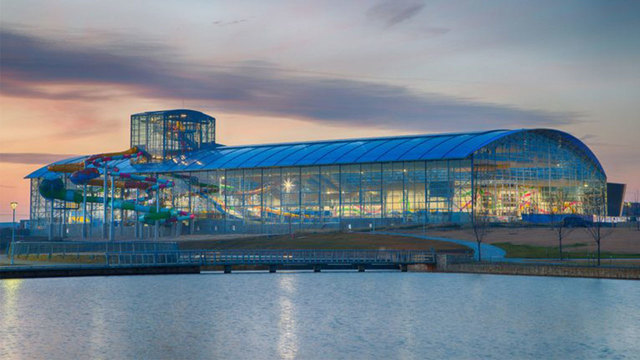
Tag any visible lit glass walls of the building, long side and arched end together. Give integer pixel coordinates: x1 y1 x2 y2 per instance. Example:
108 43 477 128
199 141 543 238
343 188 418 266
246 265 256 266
25 129 606 236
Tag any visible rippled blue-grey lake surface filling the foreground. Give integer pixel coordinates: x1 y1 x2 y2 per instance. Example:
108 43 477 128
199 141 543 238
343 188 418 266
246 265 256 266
0 272 640 359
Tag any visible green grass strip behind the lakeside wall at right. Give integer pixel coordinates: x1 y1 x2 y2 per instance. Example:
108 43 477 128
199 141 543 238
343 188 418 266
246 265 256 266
492 242 640 259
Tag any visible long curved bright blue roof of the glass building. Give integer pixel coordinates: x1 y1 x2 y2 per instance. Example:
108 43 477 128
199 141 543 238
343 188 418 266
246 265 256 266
27 129 604 178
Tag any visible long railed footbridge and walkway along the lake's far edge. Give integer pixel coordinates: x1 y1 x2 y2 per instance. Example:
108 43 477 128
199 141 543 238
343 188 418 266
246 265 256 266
9 241 444 272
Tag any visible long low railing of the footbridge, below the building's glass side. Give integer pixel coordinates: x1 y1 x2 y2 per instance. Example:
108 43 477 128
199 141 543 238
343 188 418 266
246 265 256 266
105 250 435 266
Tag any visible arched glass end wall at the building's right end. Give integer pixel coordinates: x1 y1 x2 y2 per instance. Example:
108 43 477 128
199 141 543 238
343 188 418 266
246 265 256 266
473 131 606 221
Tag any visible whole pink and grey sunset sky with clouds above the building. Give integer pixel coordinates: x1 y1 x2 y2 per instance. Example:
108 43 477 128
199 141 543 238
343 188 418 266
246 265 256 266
0 0 640 221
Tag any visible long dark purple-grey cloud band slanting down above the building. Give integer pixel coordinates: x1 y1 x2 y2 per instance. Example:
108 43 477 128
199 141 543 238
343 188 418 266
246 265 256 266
0 30 576 131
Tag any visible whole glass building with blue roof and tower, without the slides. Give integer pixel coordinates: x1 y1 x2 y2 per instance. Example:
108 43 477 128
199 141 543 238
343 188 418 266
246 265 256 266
27 110 606 239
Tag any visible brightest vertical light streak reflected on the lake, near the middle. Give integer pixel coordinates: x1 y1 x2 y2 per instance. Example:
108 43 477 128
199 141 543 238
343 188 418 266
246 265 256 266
278 274 298 359
